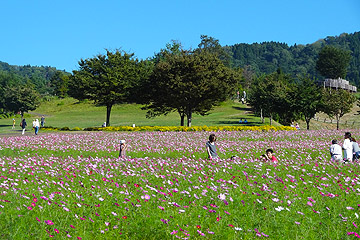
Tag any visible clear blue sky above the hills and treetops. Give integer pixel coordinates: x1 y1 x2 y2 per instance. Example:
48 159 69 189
0 0 360 72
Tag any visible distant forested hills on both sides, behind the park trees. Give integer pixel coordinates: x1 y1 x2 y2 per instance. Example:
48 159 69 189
0 32 360 95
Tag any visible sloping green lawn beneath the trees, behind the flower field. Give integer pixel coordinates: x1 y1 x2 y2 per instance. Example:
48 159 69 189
0 98 276 134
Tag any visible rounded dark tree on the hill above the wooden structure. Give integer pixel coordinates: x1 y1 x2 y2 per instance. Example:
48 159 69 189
316 46 351 79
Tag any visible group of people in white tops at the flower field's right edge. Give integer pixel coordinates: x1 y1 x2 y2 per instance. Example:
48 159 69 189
330 132 360 163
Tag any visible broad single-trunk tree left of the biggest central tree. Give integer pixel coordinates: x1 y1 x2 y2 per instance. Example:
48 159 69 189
68 50 146 126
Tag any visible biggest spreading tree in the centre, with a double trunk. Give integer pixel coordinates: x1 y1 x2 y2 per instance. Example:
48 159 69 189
144 49 240 126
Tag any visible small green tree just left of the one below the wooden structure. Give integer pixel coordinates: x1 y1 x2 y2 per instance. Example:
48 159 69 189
296 75 322 130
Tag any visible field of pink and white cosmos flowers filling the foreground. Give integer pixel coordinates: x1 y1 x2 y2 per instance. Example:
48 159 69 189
0 130 360 239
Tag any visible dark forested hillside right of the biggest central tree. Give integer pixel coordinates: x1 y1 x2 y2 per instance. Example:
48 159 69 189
224 32 360 87
